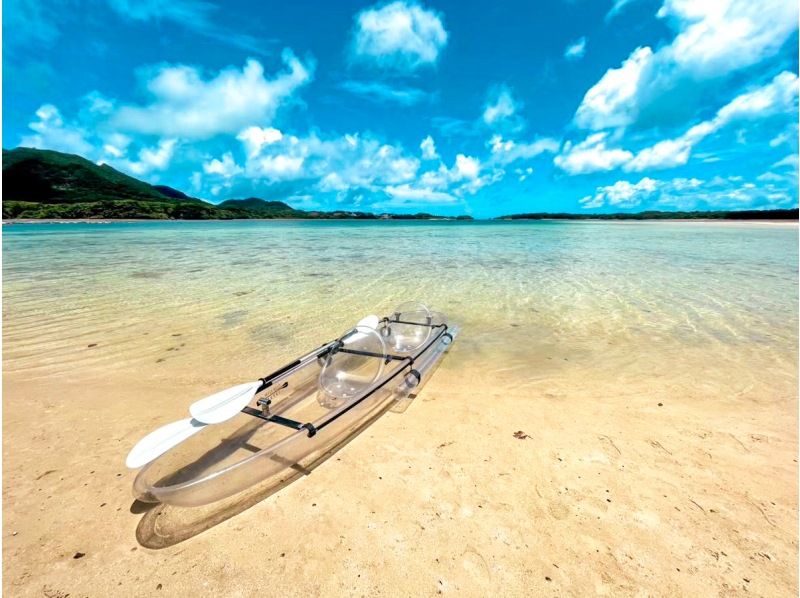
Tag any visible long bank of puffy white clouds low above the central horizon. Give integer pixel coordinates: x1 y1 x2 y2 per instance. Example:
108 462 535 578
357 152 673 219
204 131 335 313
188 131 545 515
203 128 504 206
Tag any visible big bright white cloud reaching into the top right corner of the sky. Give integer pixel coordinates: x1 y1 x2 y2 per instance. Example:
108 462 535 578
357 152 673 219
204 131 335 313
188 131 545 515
575 0 798 130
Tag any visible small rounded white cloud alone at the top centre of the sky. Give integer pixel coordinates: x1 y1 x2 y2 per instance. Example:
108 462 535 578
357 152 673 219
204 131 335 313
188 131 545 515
352 1 447 70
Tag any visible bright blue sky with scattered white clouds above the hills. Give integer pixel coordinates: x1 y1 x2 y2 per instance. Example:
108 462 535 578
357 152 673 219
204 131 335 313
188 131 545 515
3 0 798 217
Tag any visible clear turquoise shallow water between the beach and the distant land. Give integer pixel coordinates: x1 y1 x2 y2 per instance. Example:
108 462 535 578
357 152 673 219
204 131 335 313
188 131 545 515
3 221 798 394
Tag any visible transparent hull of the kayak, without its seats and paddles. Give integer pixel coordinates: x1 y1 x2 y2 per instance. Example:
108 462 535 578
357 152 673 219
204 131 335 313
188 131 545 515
134 314 458 507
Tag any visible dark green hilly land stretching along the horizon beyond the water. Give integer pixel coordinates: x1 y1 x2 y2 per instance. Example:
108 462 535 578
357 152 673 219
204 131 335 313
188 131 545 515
2 147 798 220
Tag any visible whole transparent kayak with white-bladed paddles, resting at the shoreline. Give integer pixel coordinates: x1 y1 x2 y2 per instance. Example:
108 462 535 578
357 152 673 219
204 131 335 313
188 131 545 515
129 304 458 507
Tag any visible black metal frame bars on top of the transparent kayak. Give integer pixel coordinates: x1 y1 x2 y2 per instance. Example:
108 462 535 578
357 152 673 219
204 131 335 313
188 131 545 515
242 314 453 438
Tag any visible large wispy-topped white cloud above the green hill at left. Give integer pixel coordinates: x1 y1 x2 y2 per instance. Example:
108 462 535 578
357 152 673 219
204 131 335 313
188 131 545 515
112 49 312 139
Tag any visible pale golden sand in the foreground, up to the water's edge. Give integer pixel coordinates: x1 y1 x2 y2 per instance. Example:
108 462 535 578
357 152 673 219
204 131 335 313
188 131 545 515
3 336 798 597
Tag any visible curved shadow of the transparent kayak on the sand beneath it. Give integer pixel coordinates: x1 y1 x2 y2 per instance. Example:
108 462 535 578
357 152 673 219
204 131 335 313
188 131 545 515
130 403 392 549
